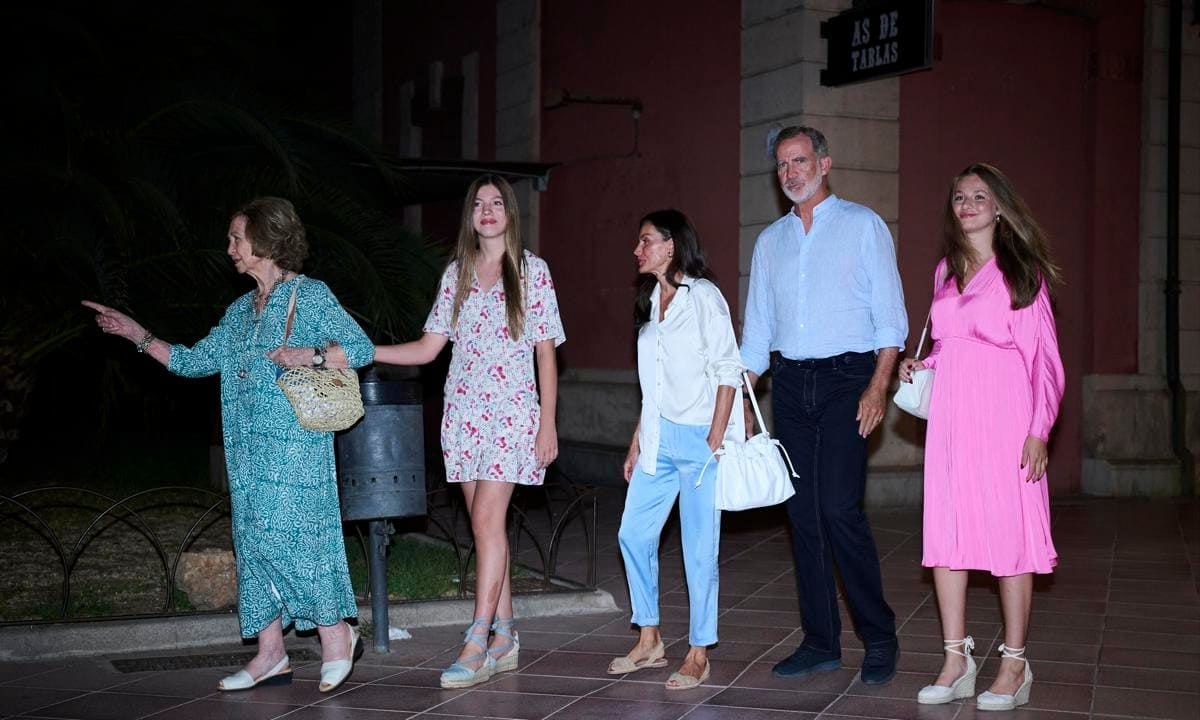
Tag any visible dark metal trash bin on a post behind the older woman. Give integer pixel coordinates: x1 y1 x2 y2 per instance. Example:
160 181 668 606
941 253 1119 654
335 368 425 654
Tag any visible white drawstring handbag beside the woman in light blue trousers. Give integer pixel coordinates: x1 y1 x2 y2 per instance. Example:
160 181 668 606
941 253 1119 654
696 373 798 510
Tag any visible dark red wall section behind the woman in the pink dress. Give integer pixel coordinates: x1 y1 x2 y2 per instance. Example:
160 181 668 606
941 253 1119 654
900 1 1141 493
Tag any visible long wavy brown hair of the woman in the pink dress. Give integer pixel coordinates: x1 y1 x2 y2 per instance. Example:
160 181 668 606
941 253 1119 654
942 162 1062 310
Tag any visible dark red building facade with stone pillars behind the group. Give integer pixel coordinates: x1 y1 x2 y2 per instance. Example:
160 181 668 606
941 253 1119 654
354 0 1200 504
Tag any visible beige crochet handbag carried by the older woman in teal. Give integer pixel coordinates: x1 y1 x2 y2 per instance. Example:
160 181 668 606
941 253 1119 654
275 277 362 432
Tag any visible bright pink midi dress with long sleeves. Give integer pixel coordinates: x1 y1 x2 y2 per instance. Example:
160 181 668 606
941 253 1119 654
922 258 1063 576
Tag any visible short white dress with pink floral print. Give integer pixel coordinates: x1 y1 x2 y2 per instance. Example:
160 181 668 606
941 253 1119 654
425 251 566 485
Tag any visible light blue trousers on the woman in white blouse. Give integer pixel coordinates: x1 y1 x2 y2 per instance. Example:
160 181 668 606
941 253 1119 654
617 419 721 647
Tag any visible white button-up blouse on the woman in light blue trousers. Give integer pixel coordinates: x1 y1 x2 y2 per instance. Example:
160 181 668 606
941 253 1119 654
637 277 745 475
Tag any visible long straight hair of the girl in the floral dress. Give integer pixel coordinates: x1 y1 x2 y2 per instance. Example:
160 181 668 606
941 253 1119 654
450 175 524 340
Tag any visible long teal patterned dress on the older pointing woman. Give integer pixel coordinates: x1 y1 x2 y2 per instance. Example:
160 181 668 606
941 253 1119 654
167 276 374 637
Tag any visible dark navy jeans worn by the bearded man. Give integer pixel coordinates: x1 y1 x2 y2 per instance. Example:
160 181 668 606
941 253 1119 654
772 353 896 655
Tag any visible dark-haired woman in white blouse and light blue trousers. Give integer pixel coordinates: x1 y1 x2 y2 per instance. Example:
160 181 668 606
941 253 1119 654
608 210 745 690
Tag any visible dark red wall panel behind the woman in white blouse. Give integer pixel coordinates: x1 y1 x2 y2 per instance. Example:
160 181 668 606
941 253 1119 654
540 0 740 367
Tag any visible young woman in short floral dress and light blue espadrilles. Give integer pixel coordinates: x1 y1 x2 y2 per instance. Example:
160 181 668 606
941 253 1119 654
376 175 566 688
